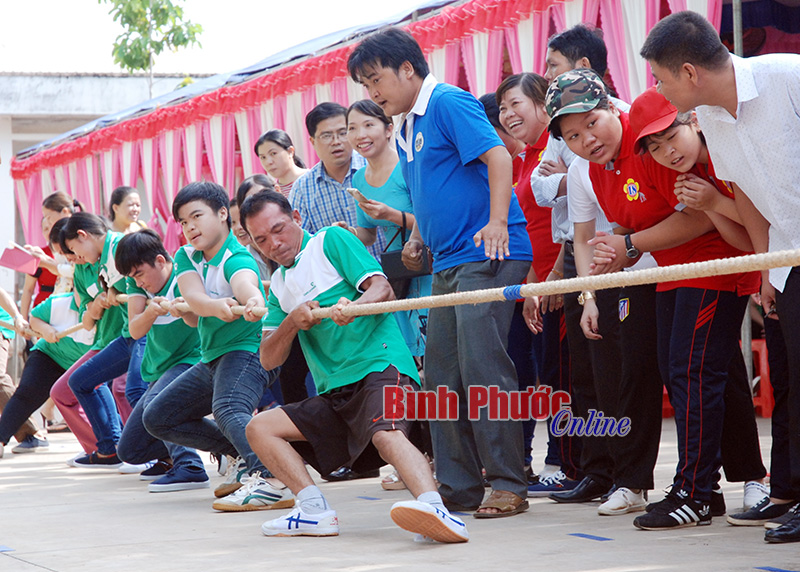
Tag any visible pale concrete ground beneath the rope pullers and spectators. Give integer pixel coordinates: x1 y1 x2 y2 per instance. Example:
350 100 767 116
0 419 800 572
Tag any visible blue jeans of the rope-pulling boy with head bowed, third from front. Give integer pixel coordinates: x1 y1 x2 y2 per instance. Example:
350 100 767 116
117 360 203 469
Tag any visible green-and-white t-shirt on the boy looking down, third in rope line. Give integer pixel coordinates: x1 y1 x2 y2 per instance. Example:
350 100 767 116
127 264 200 382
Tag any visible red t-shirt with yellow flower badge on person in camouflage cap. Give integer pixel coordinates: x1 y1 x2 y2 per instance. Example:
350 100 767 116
589 113 738 292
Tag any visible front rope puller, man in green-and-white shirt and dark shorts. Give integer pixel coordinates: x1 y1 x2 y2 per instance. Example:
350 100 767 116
240 191 469 542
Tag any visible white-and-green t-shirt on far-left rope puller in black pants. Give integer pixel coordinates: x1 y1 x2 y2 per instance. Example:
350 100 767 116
31 292 94 369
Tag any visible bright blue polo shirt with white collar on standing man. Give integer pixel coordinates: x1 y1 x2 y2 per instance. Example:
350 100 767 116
397 75 532 272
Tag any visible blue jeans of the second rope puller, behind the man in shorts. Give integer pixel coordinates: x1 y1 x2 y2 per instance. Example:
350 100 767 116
142 350 279 475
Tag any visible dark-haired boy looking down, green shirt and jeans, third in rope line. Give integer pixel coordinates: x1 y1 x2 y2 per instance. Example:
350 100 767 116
114 229 209 493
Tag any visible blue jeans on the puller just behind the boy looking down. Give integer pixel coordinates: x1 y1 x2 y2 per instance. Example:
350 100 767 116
69 336 144 455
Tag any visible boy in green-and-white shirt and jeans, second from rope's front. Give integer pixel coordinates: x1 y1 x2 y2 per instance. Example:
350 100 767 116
143 181 294 512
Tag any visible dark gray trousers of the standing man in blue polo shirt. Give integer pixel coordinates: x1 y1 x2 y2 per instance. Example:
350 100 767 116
425 260 530 506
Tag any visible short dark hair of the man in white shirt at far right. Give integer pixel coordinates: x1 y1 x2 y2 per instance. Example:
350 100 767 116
639 10 730 75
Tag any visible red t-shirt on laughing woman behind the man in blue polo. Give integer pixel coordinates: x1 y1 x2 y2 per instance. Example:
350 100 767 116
514 130 561 282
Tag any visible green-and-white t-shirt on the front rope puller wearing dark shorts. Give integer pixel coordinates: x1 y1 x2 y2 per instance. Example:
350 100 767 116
263 227 419 393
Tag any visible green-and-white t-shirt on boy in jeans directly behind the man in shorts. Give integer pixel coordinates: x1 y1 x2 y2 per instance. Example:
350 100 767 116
175 232 264 363
